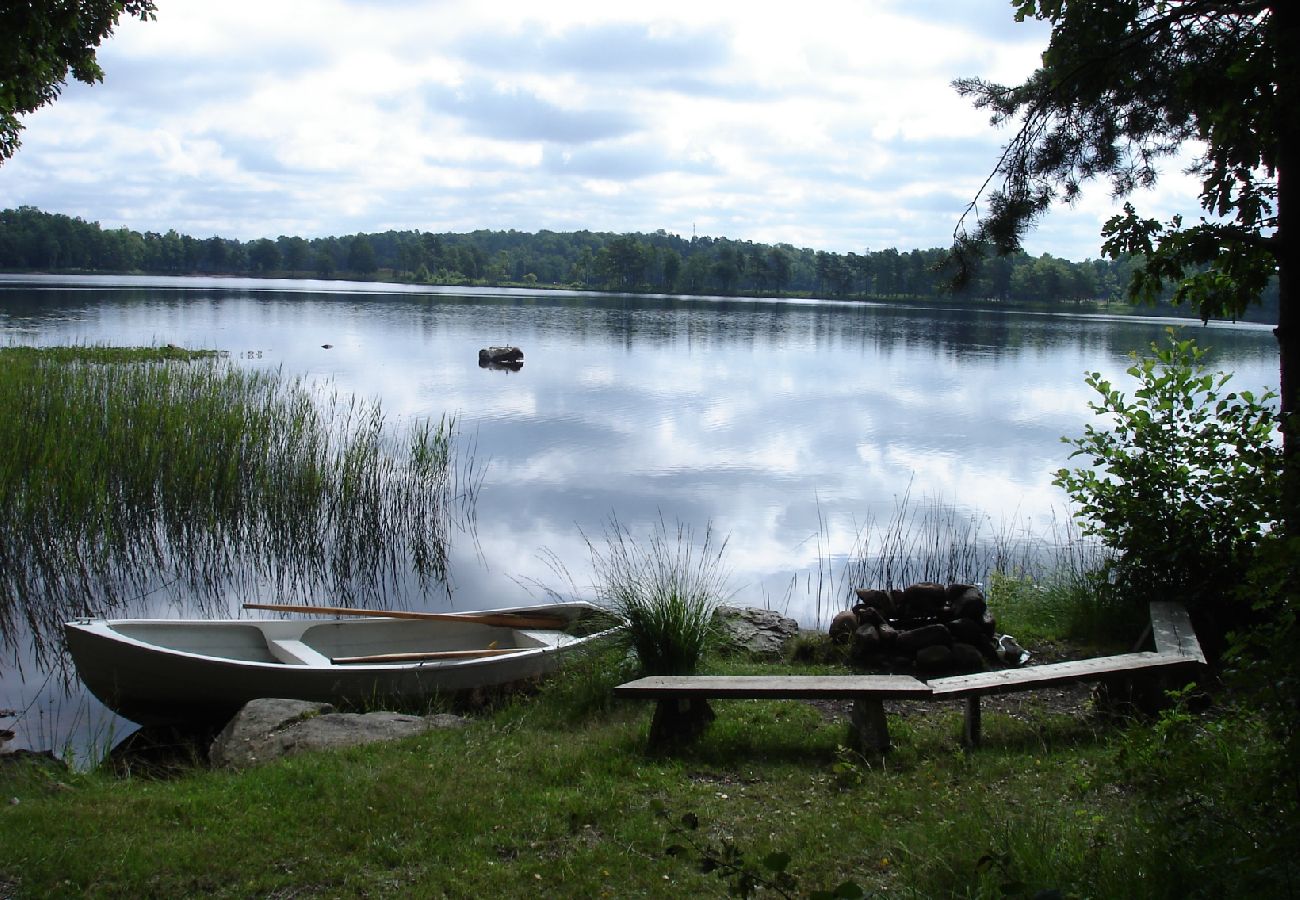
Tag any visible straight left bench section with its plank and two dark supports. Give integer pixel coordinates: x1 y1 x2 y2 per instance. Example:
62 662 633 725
614 675 931 752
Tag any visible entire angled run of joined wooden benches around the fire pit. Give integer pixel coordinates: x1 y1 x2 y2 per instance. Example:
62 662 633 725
614 601 1205 752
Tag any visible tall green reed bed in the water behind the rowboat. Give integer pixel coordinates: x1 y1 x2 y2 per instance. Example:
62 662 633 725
0 347 481 661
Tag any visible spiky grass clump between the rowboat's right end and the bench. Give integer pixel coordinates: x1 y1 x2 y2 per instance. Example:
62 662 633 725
588 519 727 675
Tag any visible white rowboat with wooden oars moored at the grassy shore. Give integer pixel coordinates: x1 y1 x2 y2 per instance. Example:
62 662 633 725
64 602 618 724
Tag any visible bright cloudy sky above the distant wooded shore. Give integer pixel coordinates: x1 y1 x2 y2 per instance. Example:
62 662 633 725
0 0 1195 259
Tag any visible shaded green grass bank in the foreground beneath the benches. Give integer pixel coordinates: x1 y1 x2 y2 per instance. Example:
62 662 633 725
0 637 1295 897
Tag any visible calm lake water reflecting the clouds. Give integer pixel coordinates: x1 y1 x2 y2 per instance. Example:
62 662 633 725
0 276 1277 744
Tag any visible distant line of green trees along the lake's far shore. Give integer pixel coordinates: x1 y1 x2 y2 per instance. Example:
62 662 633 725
0 207 1277 321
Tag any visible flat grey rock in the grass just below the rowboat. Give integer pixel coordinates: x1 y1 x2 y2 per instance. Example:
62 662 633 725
209 700 465 769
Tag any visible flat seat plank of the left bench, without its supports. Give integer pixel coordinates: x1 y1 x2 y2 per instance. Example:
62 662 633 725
614 675 930 700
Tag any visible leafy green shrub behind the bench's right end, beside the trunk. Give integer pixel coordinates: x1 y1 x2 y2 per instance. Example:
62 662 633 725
1054 329 1282 639
